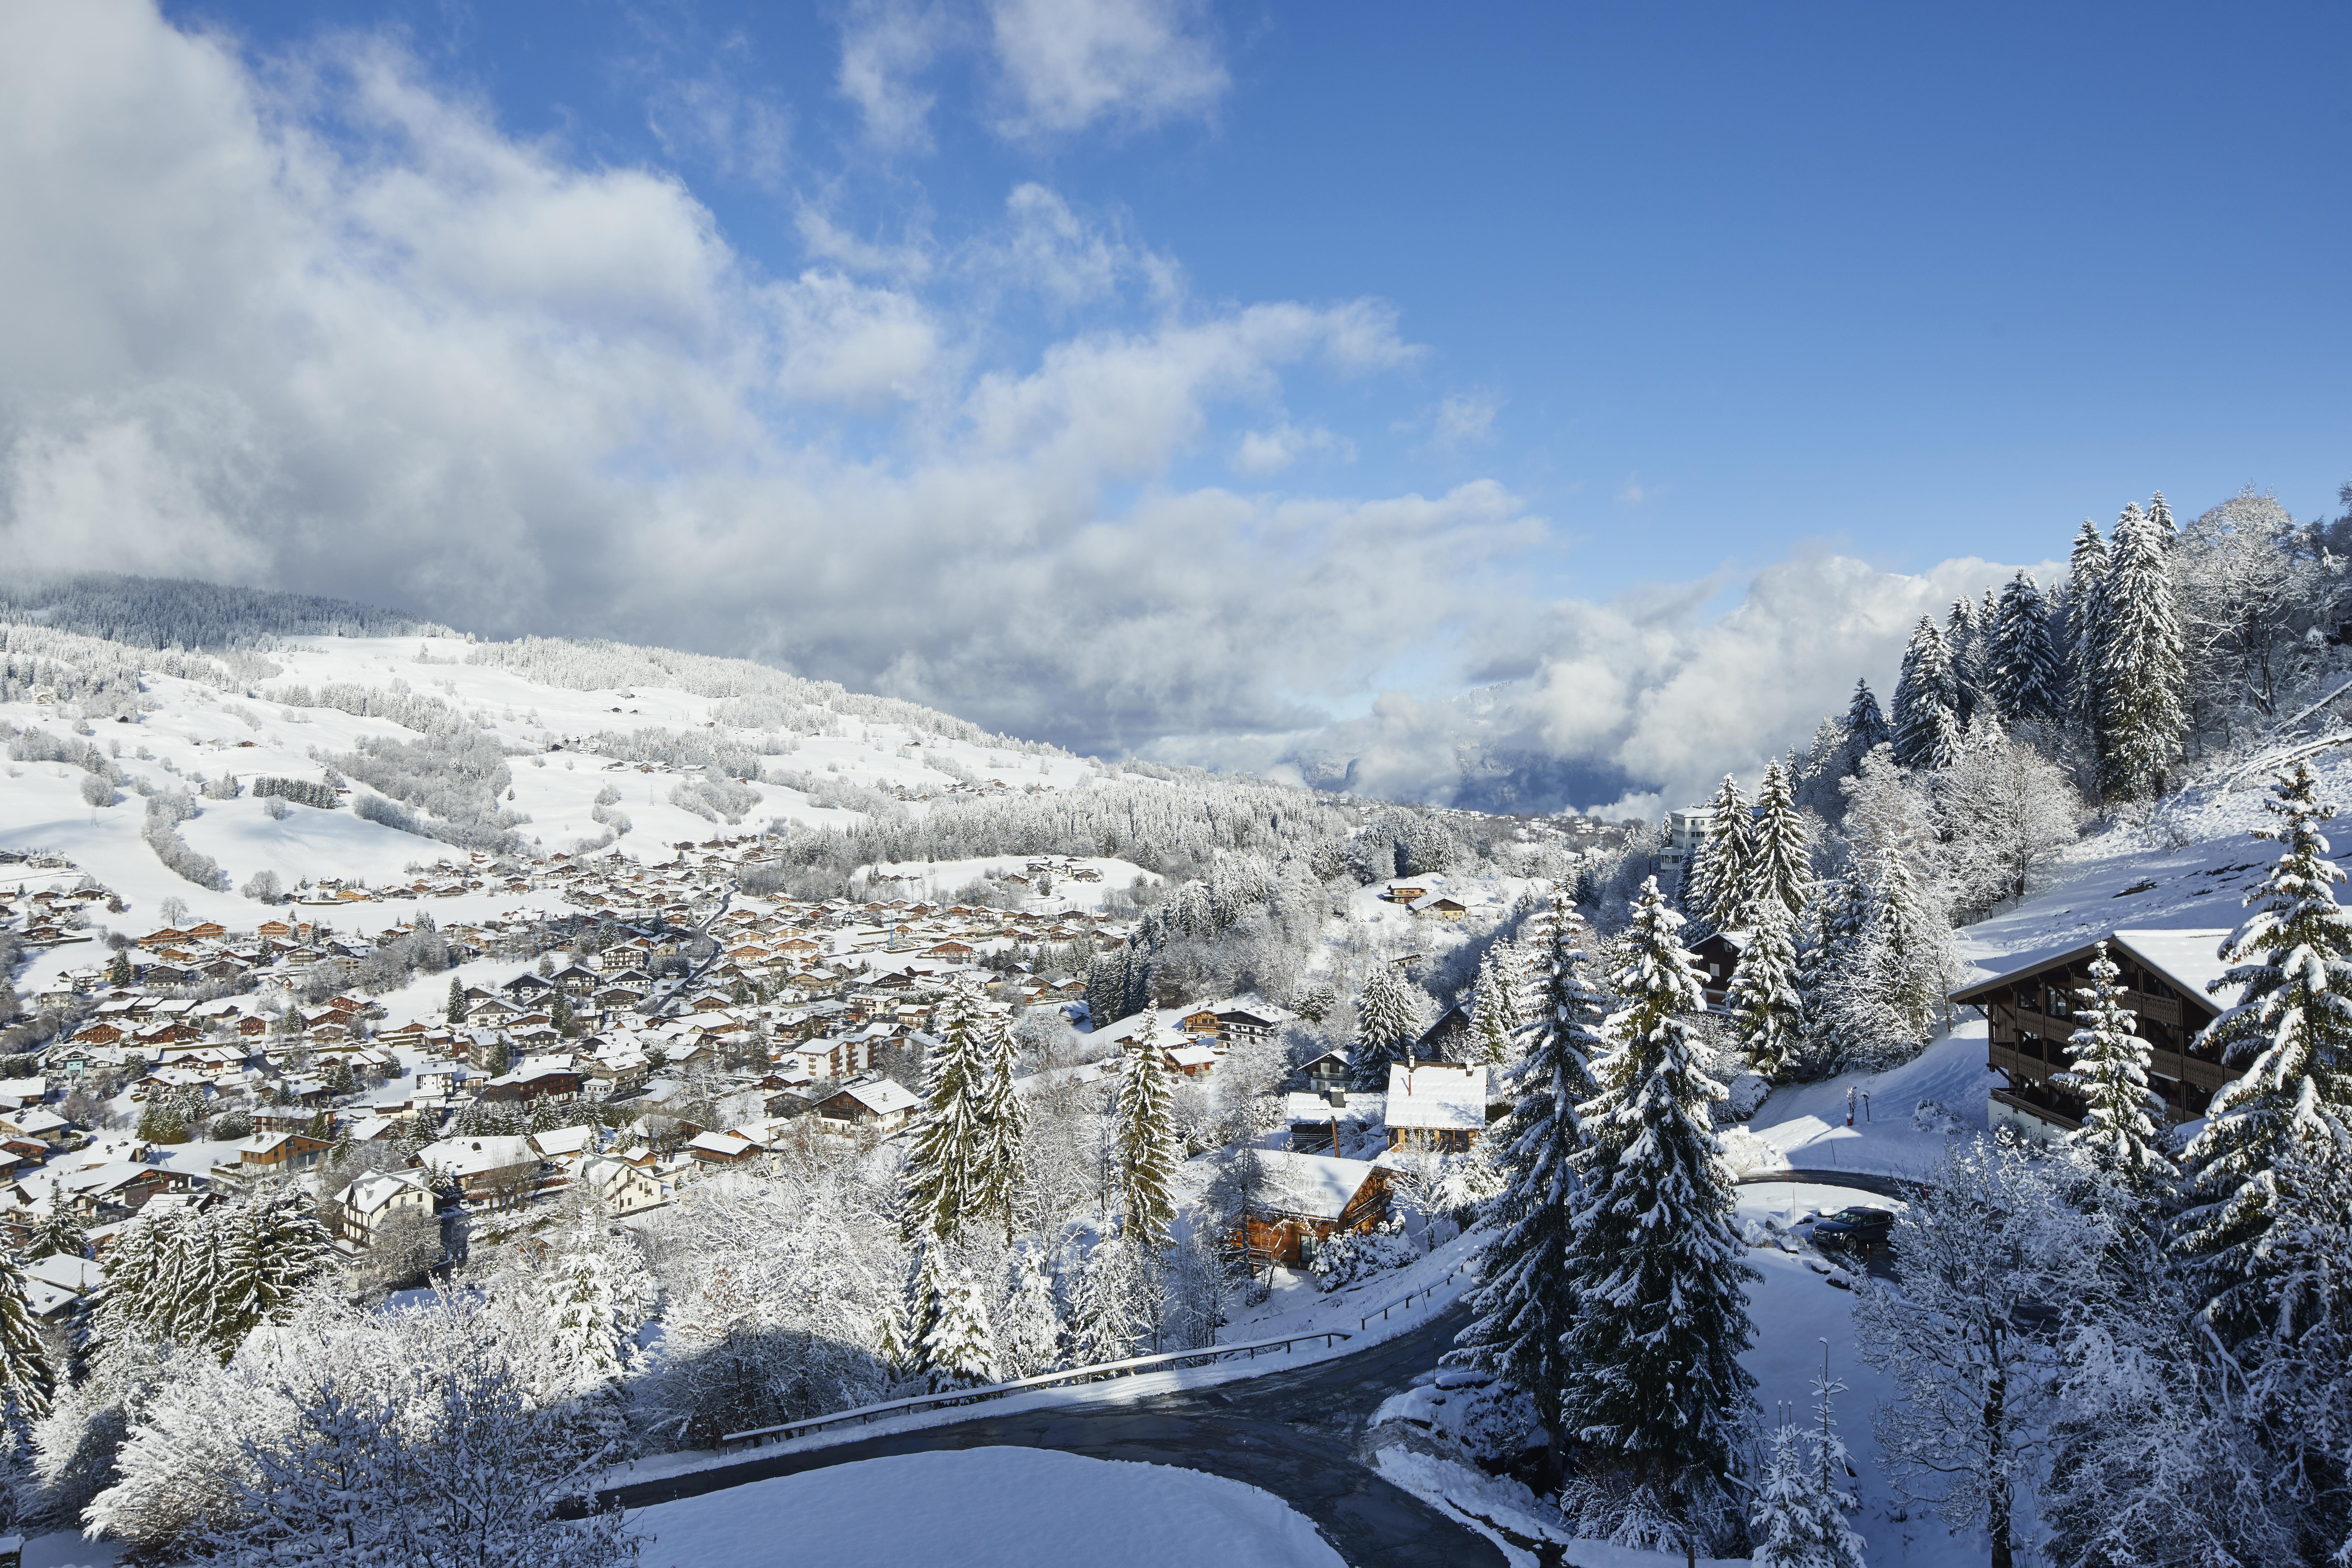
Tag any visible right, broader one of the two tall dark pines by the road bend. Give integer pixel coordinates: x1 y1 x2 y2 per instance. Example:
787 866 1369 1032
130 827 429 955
1562 881 1762 1540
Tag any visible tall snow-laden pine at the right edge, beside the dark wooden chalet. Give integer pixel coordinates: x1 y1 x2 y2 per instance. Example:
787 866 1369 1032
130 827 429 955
2173 762 2352 1338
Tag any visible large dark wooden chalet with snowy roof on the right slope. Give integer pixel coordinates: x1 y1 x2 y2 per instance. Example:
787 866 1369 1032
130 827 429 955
1952 928 2239 1138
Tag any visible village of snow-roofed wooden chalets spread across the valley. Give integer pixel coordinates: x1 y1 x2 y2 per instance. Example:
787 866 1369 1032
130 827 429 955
0 837 1500 1321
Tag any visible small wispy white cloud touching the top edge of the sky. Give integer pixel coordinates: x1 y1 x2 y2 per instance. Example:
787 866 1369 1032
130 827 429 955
988 0 1230 136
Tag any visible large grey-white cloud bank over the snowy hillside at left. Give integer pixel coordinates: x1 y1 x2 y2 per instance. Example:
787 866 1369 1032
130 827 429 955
0 0 1486 748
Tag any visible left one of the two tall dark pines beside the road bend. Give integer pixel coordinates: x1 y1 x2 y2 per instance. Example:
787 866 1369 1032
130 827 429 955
1447 893 1609 1469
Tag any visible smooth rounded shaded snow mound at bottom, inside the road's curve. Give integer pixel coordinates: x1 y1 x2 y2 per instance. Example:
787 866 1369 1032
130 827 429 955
635 1448 1341 1568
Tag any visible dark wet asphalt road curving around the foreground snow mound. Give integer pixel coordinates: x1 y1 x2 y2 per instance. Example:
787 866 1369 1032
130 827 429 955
598 1307 1505 1568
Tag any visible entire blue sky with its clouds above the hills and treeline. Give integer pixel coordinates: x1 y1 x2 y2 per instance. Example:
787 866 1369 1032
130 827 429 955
0 0 2352 804
